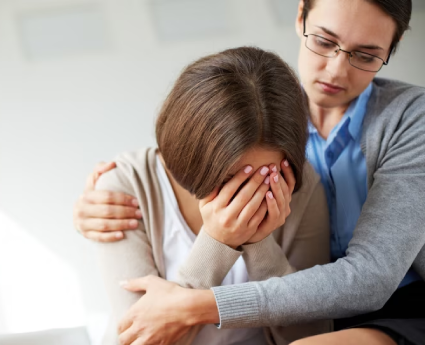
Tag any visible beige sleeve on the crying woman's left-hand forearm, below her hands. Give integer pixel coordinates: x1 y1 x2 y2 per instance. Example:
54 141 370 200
178 230 243 289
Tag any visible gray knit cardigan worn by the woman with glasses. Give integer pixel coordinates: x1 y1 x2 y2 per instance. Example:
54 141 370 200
213 78 425 328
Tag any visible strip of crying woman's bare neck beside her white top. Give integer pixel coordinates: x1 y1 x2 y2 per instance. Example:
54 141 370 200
158 153 203 235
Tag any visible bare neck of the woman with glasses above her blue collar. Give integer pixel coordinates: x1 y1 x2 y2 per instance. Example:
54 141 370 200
309 102 349 139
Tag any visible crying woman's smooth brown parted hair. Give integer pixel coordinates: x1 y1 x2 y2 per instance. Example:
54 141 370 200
156 47 307 199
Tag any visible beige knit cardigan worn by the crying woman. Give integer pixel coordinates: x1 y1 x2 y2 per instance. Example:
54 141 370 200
96 148 332 345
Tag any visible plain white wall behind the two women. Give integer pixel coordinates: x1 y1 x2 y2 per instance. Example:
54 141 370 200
0 0 425 338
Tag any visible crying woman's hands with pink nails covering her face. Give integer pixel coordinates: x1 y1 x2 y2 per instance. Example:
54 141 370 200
199 160 295 248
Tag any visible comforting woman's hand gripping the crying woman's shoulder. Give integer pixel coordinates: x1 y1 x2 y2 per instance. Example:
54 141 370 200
73 162 142 242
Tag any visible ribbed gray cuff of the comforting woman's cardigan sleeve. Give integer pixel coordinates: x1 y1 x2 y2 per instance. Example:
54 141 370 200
211 283 260 328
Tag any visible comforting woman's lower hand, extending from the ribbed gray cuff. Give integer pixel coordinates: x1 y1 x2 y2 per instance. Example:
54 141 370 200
118 276 219 345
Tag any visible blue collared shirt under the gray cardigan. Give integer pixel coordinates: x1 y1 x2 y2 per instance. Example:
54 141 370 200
307 83 420 287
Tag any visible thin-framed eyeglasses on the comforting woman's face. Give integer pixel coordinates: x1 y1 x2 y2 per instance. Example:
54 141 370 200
303 16 393 72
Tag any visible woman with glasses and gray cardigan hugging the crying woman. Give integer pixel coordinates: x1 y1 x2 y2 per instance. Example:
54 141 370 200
75 0 425 345
